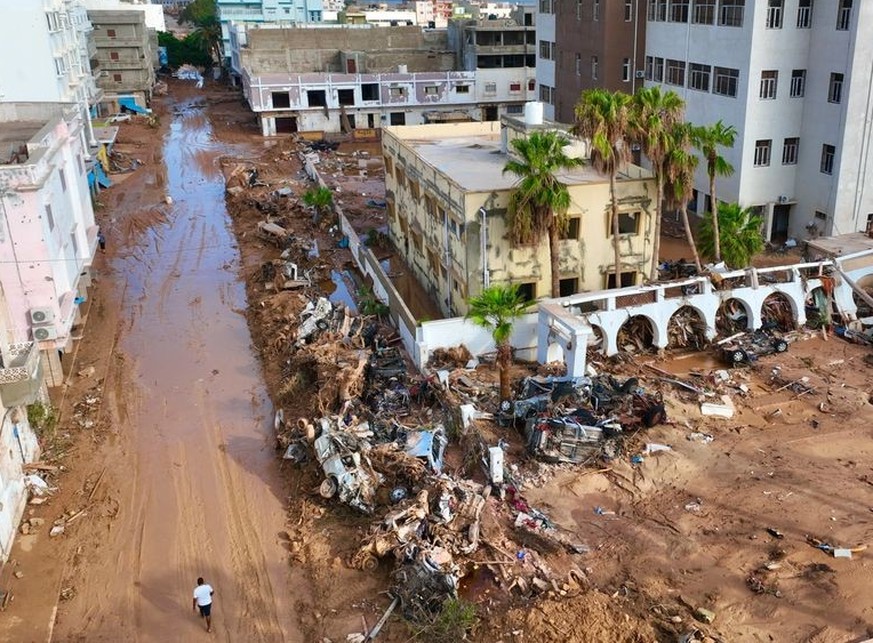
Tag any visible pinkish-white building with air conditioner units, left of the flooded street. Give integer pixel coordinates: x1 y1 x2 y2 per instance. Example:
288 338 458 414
0 103 97 386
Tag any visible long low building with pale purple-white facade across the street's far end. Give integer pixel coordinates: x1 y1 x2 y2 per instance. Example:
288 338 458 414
230 14 535 136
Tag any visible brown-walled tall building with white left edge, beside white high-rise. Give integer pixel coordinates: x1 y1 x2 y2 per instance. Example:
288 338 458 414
537 0 644 123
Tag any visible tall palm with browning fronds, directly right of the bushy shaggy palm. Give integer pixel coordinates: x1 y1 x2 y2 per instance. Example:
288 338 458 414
573 89 631 288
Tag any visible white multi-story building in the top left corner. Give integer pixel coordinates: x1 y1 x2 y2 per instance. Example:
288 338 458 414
0 0 102 153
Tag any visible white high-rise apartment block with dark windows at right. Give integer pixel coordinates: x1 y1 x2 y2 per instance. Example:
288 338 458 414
645 0 873 242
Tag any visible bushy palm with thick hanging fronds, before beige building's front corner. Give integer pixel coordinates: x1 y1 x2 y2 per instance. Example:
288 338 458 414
503 131 583 297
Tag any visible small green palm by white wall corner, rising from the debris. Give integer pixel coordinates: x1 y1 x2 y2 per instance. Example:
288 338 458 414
467 284 527 402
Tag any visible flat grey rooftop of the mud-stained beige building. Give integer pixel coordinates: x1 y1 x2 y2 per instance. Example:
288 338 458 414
387 122 629 192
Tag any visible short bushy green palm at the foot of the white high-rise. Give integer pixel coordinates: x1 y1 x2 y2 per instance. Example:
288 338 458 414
698 203 764 268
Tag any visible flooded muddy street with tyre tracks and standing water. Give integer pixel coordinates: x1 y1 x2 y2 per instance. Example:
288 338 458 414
54 100 302 641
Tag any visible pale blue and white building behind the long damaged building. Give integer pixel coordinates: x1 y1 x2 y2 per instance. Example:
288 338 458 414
215 0 324 65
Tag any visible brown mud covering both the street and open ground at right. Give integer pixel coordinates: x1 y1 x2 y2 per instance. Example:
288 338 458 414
0 83 873 643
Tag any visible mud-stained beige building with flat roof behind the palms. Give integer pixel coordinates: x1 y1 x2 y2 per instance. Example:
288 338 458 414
382 117 655 315
